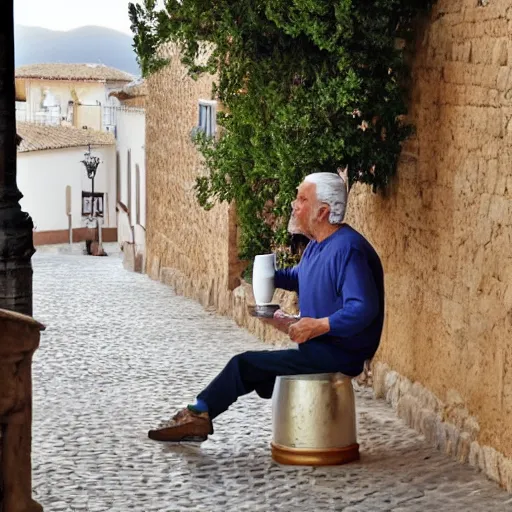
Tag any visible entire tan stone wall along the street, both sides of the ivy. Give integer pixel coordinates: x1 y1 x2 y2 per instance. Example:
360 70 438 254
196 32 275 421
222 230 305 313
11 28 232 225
146 0 512 490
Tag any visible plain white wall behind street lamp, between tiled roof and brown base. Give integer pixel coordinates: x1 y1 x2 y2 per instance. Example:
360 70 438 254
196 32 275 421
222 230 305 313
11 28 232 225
18 145 116 231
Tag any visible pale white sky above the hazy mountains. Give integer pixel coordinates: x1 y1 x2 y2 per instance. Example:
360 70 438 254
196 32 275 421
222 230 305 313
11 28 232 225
13 0 164 34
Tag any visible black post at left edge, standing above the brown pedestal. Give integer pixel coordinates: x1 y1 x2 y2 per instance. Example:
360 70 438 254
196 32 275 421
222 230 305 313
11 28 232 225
0 0 35 315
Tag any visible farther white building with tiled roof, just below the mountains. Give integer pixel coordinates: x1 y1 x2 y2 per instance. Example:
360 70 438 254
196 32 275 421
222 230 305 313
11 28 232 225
16 64 134 131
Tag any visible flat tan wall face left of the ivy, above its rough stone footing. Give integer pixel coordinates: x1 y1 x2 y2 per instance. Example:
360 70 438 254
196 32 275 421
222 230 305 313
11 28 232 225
146 47 229 293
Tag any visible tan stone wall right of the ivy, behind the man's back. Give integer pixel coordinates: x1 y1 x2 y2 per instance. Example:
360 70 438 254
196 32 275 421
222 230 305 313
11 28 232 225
349 0 512 487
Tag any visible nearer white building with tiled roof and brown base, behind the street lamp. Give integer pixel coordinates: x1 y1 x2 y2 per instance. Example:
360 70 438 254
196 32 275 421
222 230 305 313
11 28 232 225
17 122 117 245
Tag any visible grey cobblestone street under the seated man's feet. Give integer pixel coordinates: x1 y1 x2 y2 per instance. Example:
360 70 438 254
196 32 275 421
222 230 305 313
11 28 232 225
33 247 512 512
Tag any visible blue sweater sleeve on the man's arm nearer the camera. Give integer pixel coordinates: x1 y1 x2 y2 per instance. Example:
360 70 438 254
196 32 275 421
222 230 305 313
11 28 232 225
329 250 379 337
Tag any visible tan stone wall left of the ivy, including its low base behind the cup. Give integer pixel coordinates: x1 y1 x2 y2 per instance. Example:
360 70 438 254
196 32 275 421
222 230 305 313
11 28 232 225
145 46 295 343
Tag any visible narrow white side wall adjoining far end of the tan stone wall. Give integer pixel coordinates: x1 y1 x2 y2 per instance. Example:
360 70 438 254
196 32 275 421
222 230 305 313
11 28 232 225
117 108 146 227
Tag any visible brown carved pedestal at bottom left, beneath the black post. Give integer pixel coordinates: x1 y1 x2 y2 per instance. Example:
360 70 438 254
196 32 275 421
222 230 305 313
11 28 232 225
0 309 44 512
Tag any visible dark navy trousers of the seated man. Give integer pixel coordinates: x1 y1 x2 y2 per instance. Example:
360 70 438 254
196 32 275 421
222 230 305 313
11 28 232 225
197 349 348 419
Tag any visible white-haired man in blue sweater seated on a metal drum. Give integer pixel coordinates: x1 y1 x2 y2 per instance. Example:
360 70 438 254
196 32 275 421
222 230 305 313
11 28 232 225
148 173 384 441
